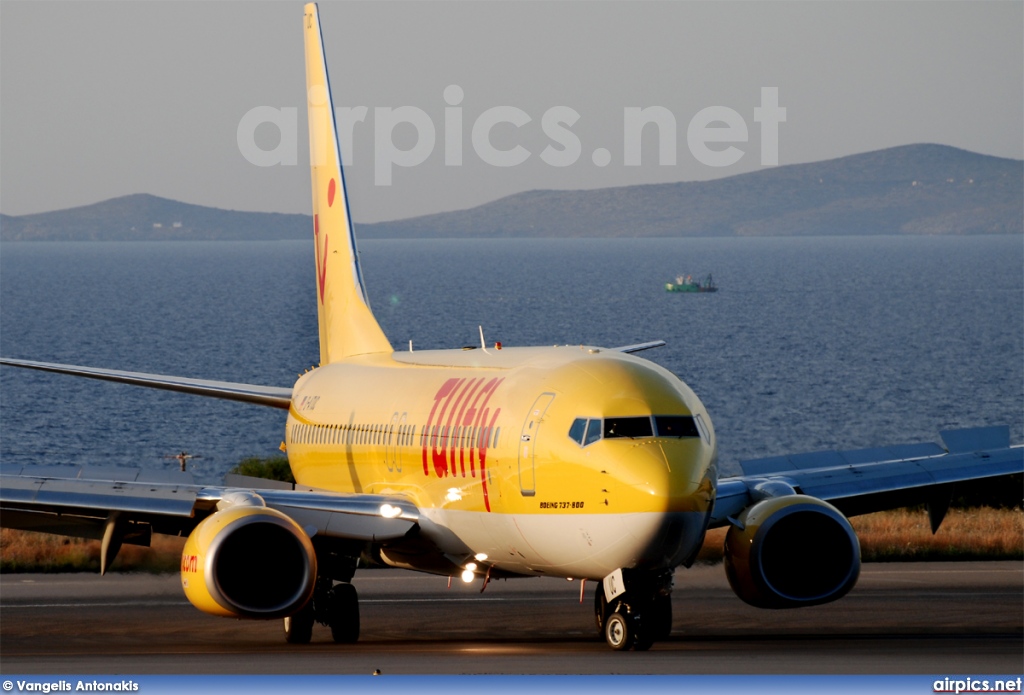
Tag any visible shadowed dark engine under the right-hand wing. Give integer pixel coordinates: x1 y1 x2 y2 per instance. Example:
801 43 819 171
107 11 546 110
725 494 860 608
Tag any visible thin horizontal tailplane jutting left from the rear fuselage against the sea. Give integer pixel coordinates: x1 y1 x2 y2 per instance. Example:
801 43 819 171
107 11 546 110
0 357 292 410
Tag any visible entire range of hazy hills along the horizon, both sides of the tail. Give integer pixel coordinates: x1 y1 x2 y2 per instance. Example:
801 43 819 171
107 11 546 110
0 144 1024 241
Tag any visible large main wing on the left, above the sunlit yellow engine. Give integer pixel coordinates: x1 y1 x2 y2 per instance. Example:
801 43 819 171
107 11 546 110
0 464 419 546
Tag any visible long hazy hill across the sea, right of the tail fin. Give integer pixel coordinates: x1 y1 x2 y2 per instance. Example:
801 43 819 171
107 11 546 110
359 144 1024 237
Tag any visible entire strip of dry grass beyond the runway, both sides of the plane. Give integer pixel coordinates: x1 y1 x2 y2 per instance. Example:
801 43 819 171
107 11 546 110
0 508 1024 572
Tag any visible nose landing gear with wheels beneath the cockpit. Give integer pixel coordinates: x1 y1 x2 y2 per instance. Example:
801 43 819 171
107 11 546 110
594 570 672 652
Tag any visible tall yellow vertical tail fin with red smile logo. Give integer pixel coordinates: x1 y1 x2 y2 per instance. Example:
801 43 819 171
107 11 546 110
303 3 391 364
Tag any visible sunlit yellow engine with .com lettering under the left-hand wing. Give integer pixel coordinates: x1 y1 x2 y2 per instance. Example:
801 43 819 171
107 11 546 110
181 506 316 619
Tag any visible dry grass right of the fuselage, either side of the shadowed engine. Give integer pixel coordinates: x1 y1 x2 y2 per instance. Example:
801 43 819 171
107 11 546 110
698 507 1024 562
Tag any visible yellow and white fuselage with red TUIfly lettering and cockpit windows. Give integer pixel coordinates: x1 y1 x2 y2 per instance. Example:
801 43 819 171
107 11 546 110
287 346 717 579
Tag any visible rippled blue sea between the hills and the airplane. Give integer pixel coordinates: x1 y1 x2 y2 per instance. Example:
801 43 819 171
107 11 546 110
0 236 1024 482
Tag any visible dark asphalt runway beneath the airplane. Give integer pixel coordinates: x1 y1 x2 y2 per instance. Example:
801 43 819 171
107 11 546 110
0 562 1024 675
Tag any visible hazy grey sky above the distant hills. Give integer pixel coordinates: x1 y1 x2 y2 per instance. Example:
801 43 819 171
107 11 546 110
0 0 1024 221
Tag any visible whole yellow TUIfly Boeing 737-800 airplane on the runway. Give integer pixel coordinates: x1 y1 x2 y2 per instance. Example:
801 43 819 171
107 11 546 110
0 4 1024 650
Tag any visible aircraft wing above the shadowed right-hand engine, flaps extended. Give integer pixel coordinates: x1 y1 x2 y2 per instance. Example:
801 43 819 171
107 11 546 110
712 427 1024 531
